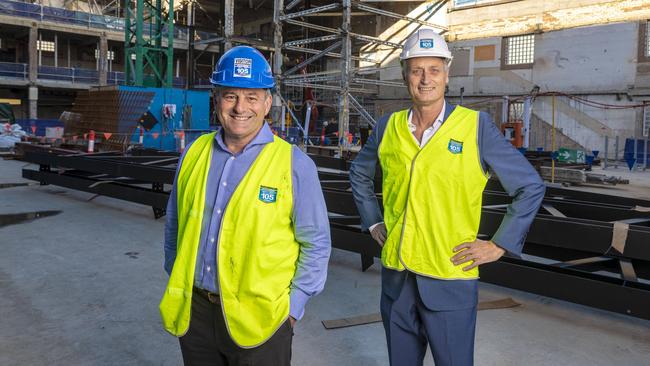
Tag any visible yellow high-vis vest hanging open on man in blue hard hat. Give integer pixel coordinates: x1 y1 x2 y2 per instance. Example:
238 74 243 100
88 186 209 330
160 133 299 348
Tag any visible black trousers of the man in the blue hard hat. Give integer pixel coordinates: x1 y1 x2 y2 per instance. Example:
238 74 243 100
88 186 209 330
179 289 293 366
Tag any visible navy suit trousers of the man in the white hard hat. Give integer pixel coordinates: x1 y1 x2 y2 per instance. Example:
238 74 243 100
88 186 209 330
381 273 476 366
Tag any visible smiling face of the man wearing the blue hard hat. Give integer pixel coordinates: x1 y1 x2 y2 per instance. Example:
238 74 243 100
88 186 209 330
216 88 271 139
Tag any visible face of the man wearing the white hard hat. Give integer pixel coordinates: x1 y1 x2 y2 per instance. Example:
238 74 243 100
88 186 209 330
404 57 449 106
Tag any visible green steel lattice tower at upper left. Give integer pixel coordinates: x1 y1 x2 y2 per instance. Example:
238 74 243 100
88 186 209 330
124 0 174 88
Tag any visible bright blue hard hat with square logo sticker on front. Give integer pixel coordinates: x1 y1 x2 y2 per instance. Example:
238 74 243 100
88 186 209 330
210 46 275 89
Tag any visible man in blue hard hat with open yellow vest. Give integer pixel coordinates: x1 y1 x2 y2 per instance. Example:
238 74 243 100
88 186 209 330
160 46 331 365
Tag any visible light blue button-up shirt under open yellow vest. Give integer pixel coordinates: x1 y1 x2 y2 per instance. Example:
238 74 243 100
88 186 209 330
164 124 331 319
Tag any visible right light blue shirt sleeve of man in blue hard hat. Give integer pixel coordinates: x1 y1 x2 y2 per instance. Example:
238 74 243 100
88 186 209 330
289 147 332 319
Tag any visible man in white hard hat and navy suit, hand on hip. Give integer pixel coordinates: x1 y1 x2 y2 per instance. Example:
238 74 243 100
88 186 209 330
350 29 545 366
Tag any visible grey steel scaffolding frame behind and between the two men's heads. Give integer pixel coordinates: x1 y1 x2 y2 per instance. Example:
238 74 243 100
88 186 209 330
220 0 447 149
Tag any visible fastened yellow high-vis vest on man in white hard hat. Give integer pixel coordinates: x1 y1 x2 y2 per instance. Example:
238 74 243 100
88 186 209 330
379 106 488 280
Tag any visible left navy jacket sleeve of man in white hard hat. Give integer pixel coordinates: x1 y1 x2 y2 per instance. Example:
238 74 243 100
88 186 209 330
350 116 389 230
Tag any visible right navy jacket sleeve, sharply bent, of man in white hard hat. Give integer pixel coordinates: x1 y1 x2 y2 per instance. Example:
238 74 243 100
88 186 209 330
479 113 546 257
